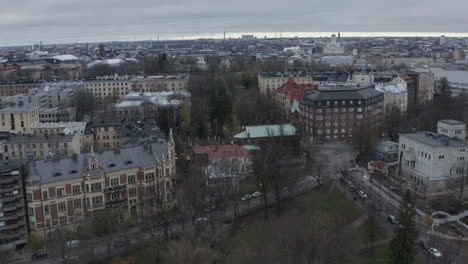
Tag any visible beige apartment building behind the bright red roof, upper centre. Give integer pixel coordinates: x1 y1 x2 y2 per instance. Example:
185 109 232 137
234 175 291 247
258 72 313 96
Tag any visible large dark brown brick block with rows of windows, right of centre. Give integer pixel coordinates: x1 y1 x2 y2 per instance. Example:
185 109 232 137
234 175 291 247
299 83 384 142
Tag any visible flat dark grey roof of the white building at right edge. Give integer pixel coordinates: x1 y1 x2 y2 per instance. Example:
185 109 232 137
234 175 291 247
400 132 468 148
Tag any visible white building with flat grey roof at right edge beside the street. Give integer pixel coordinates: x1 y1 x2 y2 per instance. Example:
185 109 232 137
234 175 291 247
399 120 468 194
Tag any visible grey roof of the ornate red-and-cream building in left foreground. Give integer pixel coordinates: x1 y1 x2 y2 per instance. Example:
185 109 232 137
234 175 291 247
26 139 168 184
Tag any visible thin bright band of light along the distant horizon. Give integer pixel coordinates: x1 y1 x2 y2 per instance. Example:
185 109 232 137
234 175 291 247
0 31 468 48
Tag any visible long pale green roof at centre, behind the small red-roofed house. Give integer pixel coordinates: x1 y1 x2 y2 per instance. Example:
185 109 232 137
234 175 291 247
234 124 296 138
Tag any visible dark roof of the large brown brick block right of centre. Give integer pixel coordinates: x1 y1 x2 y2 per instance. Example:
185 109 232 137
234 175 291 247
302 85 383 101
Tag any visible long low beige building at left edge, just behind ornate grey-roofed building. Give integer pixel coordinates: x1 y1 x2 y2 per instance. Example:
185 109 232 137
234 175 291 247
0 133 84 160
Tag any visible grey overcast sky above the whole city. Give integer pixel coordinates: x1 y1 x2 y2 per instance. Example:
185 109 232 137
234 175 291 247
0 0 468 46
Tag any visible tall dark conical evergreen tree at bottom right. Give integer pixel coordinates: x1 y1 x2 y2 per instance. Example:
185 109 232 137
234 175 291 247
390 191 418 264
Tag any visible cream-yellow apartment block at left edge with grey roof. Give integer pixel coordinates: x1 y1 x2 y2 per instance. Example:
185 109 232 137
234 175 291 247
0 106 39 134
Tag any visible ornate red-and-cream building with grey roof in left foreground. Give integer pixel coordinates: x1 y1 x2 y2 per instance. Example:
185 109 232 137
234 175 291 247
25 133 177 237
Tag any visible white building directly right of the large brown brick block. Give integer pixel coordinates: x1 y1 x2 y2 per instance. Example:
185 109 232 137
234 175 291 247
375 83 408 113
